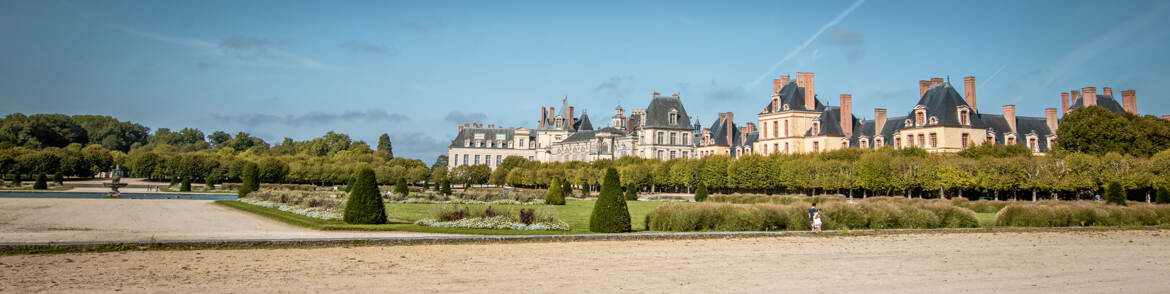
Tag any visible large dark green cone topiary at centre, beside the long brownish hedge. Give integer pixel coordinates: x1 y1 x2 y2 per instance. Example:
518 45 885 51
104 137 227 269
589 167 632 233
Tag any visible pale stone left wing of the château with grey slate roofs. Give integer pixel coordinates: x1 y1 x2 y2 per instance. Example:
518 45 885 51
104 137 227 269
447 93 696 169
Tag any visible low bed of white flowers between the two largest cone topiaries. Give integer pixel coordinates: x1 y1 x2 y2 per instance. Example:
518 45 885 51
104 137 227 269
414 204 569 231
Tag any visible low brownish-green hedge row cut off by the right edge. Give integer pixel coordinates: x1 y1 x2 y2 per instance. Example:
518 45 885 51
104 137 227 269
996 200 1170 227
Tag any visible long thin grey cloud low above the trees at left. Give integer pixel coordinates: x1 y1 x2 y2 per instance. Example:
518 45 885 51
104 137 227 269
212 108 410 127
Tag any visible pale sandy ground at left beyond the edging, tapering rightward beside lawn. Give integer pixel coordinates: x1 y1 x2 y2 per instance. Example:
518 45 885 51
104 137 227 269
0 198 444 242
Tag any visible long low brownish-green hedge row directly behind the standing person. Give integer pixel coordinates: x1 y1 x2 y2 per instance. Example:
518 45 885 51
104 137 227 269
646 200 979 231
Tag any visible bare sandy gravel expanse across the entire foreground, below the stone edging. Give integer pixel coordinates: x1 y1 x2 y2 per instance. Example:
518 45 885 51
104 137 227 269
0 231 1170 293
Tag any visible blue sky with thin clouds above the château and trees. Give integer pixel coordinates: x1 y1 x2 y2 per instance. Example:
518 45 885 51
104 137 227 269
0 0 1170 163
